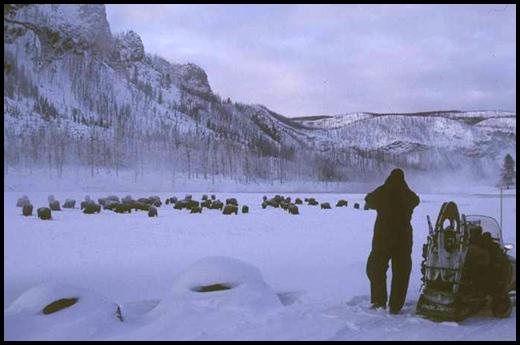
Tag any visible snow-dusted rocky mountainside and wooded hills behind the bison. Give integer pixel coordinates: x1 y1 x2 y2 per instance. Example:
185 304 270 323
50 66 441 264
4 4 516 181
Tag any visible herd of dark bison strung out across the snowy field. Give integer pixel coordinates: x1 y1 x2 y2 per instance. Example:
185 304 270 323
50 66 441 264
16 194 368 220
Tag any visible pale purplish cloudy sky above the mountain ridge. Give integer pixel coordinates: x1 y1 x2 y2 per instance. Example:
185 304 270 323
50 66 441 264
106 5 516 116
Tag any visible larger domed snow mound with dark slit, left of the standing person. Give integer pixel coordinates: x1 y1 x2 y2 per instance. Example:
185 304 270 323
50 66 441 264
165 256 281 310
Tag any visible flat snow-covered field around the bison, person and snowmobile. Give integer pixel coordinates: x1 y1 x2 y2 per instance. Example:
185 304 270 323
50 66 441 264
4 186 516 340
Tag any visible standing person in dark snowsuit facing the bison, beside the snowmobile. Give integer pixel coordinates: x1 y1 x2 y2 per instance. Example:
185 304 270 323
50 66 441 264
365 169 419 314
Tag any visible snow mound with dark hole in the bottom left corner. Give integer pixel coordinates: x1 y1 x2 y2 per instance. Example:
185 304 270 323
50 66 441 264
4 282 121 340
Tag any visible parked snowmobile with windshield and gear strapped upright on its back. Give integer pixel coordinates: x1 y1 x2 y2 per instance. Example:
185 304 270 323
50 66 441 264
416 202 516 322
